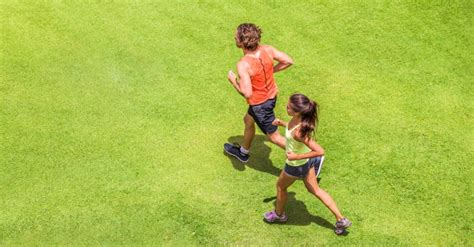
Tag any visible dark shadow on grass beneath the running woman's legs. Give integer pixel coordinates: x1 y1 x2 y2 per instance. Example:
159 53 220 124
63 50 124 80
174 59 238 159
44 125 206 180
263 192 349 236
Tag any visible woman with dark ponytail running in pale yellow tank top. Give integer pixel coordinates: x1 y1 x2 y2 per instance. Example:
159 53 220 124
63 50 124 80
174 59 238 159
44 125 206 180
264 94 352 235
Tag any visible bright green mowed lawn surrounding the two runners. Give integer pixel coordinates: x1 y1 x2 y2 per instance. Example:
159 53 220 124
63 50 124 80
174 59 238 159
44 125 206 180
0 0 474 246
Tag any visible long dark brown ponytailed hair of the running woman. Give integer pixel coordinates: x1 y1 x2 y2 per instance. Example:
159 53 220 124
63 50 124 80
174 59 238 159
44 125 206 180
290 93 319 139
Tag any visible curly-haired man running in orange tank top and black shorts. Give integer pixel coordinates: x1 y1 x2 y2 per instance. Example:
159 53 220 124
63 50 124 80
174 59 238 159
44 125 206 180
224 23 293 163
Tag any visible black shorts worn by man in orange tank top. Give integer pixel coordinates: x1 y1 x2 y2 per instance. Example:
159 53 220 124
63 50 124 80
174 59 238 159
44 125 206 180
248 98 278 134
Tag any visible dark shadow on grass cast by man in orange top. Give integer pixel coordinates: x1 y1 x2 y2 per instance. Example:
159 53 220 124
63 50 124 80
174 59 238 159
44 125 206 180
224 135 281 177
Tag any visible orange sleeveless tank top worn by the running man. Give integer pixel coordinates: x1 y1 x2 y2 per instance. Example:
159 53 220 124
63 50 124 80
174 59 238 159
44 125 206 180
242 48 278 105
